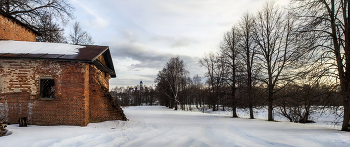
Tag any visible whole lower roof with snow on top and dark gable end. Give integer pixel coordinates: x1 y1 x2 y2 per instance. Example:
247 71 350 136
0 40 116 78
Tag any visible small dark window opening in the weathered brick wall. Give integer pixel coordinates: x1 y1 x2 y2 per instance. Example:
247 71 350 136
40 79 55 98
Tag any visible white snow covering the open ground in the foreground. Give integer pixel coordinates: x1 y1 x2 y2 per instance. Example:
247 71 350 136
0 106 350 147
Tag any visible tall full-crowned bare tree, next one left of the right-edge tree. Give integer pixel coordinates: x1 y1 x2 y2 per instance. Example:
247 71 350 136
254 2 299 121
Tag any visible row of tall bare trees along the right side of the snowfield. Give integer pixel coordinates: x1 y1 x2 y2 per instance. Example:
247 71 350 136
199 0 350 130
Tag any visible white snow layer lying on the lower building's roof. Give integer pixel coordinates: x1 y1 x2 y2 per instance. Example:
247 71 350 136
0 40 85 55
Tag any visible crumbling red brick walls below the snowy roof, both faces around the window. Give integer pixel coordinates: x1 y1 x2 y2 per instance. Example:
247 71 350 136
0 59 126 126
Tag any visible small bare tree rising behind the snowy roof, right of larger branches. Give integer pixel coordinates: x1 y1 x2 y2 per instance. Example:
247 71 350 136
69 22 94 45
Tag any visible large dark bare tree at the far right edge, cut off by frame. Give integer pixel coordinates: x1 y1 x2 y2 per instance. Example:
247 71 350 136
294 0 350 131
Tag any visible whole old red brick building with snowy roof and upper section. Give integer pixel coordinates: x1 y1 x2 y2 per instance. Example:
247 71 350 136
0 11 126 126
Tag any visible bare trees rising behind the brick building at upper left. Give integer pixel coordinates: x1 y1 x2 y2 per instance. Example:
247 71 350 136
0 0 94 44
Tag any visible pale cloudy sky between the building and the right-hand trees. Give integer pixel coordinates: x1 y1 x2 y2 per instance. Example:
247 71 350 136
66 0 288 87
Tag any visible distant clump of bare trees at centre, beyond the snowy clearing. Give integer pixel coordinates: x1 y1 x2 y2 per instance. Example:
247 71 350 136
155 56 208 110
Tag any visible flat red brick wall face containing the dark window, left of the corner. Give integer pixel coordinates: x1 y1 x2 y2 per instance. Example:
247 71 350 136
0 59 89 126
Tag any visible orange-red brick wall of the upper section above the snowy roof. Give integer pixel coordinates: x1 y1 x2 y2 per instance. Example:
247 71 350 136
0 14 36 42
